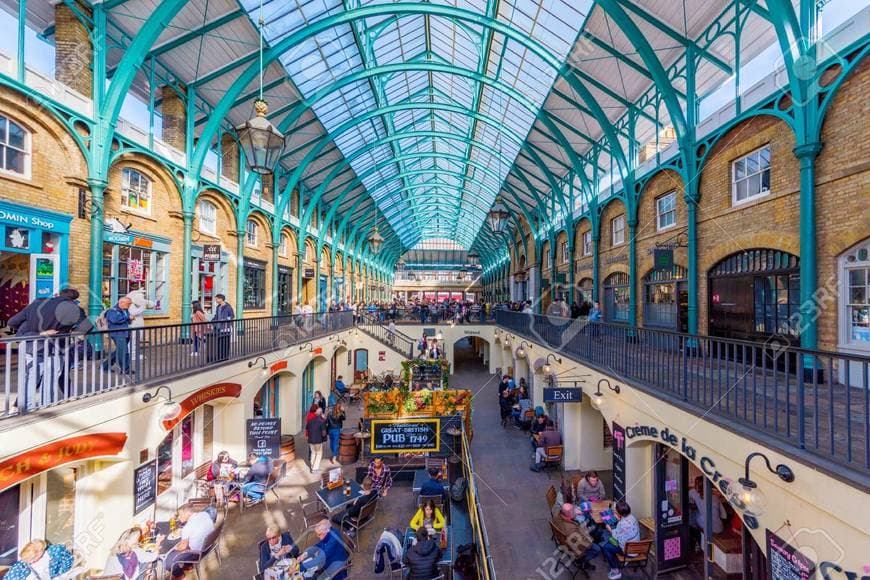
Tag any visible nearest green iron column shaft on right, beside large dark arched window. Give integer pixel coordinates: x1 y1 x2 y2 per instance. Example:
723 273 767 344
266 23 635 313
794 142 822 352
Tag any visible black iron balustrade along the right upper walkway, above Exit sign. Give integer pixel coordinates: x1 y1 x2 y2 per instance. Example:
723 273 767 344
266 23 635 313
496 310 870 475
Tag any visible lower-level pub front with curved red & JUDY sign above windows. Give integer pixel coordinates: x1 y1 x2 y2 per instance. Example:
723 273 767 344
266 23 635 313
0 433 127 566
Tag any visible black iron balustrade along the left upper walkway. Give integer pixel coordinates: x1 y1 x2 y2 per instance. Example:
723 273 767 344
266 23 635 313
0 311 353 418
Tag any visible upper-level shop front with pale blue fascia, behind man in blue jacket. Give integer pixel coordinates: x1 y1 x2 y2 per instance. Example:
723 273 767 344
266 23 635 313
102 229 172 314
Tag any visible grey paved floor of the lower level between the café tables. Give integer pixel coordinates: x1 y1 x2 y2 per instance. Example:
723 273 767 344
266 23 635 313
203 338 724 580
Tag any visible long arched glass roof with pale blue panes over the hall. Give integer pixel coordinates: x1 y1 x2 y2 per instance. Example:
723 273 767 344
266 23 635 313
242 0 591 248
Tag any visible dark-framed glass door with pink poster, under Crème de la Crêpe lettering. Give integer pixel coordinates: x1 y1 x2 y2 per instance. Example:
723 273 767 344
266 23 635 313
654 444 691 574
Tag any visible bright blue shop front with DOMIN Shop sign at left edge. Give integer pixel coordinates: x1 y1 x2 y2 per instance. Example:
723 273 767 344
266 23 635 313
0 201 72 330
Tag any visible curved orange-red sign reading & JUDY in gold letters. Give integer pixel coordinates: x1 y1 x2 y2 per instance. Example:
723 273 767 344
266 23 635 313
0 433 127 491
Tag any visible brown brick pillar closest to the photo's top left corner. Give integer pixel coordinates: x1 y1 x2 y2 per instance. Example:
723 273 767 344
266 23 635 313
54 3 94 98
